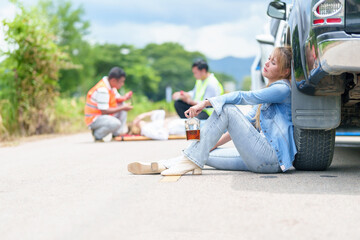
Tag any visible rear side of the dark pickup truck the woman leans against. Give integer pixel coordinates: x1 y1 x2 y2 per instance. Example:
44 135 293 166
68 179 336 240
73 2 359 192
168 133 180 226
268 0 360 170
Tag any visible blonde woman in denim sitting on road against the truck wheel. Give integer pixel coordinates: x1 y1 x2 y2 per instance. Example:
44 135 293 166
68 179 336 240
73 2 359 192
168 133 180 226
128 47 296 176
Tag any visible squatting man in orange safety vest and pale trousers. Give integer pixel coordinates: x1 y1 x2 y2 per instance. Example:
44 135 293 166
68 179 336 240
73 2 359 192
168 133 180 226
85 67 133 141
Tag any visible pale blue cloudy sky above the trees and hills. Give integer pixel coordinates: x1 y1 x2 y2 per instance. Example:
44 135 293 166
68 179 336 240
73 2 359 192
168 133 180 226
0 0 270 59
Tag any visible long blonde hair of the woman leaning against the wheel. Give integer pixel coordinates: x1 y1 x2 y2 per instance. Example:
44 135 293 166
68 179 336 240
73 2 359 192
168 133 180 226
254 46 292 130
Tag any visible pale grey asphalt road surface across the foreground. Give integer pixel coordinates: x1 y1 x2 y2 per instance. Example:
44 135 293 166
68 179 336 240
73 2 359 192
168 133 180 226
0 133 360 240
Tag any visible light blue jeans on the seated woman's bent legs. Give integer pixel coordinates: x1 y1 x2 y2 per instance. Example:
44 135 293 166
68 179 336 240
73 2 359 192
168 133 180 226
162 104 281 173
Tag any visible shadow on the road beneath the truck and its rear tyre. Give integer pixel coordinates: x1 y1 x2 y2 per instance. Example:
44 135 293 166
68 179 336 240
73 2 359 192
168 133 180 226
232 147 360 195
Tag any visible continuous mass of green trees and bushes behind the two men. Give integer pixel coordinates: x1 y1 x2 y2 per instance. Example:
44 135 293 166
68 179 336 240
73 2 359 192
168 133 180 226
0 0 239 138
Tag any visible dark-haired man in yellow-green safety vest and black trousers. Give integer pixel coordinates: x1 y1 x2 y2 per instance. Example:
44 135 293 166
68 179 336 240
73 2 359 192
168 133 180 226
172 60 224 119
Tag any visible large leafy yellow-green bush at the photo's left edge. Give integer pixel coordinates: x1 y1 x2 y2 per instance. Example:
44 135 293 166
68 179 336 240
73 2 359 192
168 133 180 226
0 0 72 135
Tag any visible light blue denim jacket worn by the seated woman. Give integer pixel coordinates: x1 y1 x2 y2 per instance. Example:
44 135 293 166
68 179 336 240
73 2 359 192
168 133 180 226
208 80 297 172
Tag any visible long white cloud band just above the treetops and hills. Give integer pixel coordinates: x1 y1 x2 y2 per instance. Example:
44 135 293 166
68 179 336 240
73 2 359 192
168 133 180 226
90 16 266 59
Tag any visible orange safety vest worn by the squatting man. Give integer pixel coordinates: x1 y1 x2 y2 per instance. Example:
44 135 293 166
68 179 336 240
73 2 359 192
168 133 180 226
85 79 117 126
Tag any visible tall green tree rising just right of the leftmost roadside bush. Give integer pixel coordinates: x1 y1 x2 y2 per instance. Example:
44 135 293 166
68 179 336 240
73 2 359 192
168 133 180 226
38 0 94 95
